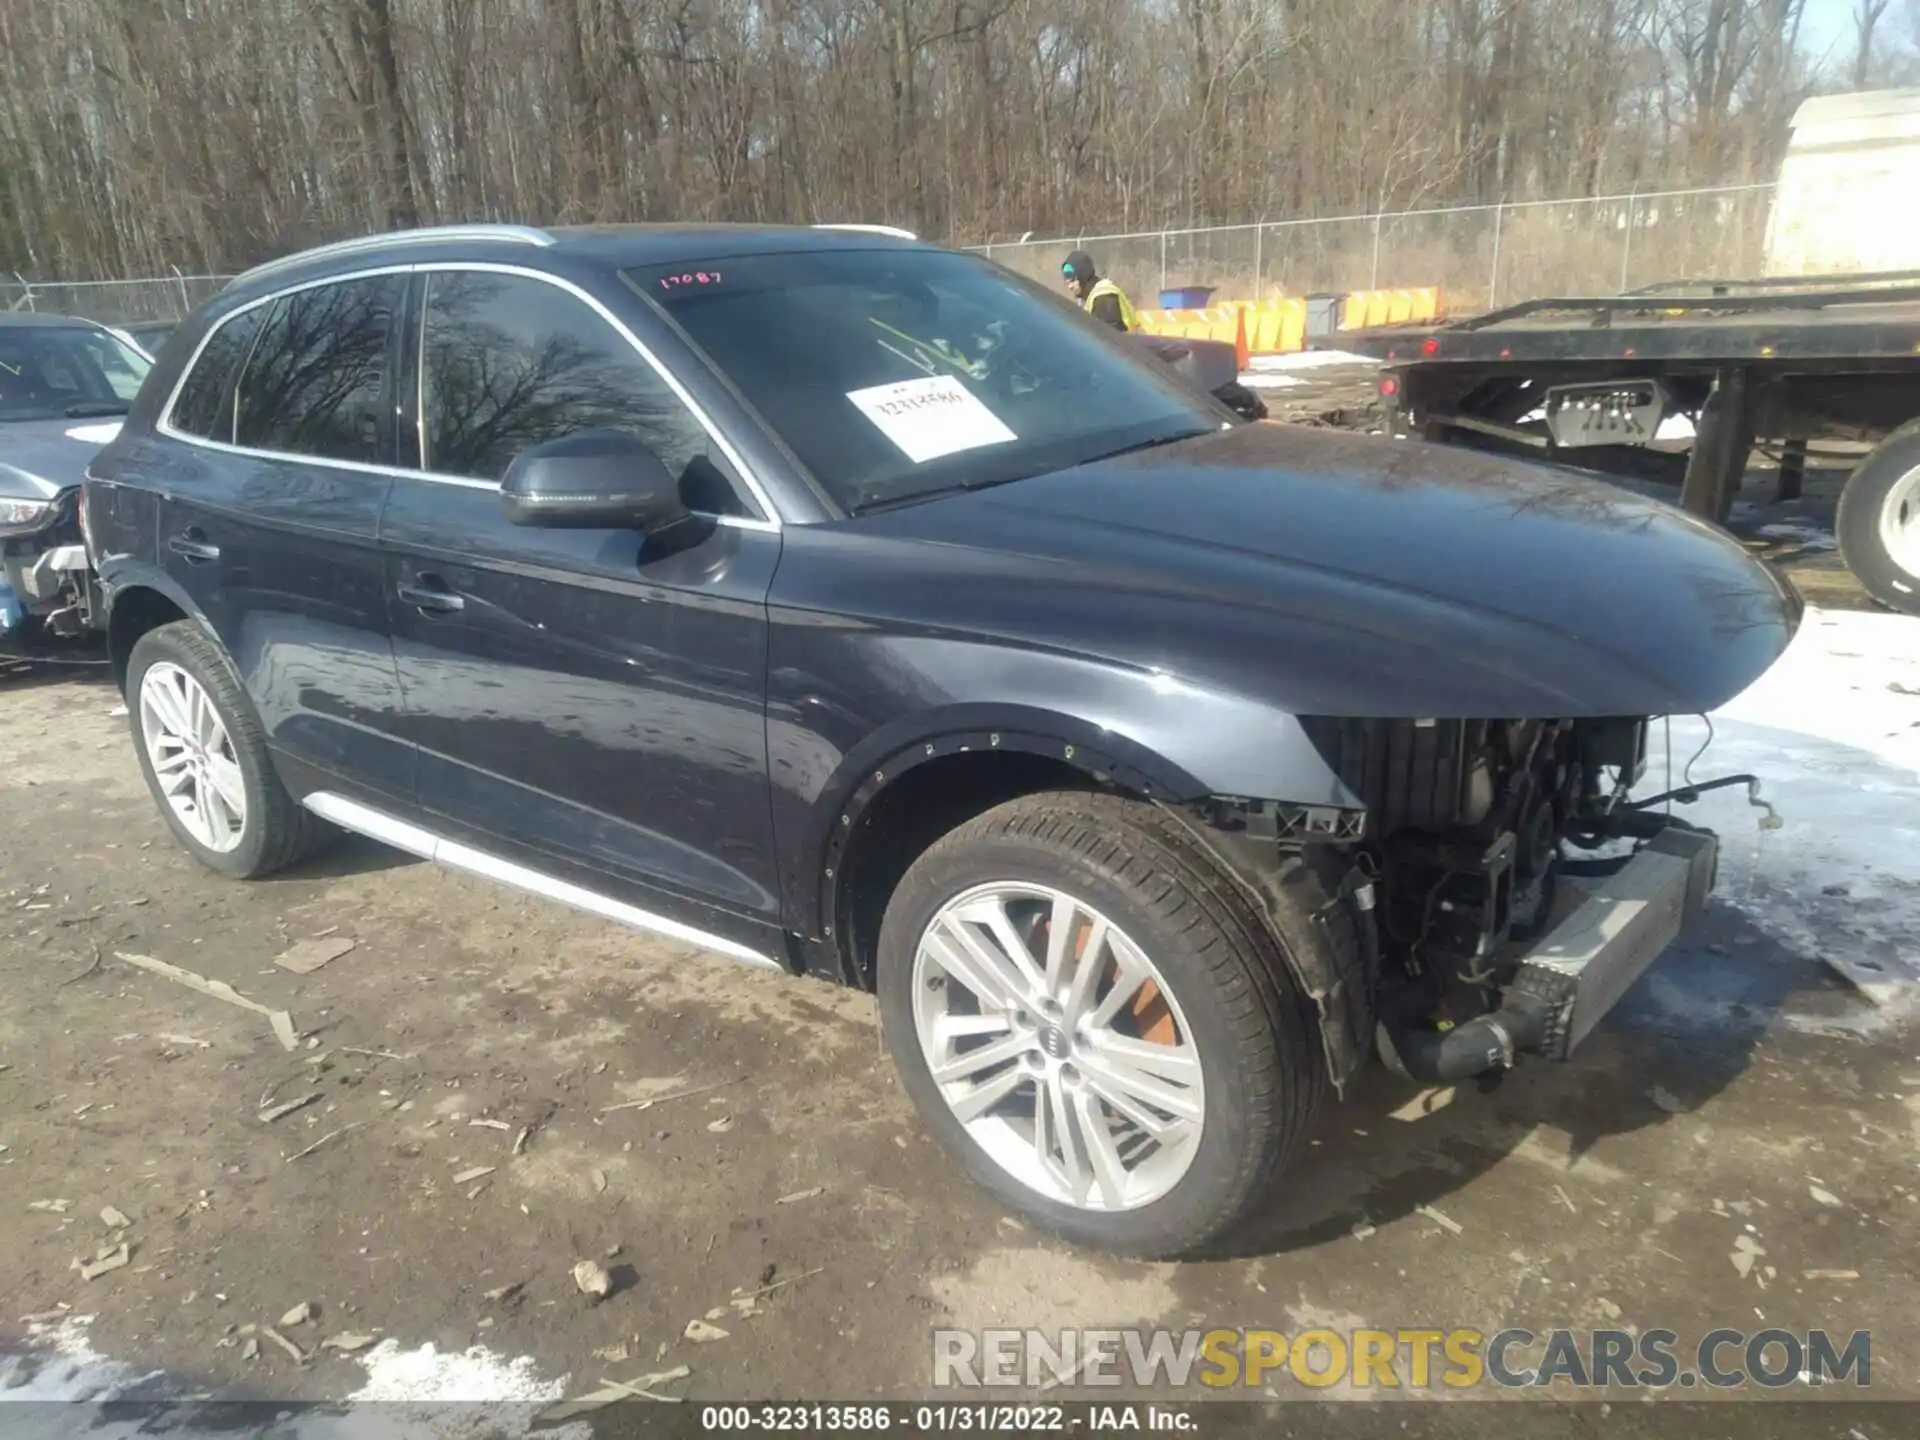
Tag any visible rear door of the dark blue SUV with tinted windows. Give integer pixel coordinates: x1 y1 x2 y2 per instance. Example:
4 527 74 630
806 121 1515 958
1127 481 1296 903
143 275 413 797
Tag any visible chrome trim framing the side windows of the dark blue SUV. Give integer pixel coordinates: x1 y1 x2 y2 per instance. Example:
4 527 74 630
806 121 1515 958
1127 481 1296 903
154 259 781 534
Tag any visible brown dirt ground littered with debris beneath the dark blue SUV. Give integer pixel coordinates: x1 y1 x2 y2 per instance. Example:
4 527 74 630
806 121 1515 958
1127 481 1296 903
0 591 1920 1440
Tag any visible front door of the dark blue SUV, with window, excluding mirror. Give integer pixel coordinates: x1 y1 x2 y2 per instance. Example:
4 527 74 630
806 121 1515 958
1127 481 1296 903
382 271 780 931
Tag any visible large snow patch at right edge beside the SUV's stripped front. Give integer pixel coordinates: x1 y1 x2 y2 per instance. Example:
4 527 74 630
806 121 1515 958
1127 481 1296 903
1640 609 1920 1020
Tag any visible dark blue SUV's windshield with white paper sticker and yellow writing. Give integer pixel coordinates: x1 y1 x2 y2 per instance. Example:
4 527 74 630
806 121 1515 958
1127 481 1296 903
626 250 1221 513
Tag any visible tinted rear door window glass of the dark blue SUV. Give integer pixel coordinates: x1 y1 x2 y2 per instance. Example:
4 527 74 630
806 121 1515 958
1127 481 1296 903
234 275 407 463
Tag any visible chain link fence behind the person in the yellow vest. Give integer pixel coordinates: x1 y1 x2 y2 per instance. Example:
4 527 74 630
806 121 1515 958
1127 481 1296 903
972 184 1774 315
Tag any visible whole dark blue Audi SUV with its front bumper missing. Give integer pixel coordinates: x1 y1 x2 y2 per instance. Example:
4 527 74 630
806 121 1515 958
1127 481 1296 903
86 225 1801 1256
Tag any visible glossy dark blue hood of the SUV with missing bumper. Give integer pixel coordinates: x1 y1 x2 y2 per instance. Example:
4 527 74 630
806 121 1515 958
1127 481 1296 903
856 424 1801 718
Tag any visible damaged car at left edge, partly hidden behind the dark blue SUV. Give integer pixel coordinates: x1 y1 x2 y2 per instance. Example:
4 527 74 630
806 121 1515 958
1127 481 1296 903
0 311 154 660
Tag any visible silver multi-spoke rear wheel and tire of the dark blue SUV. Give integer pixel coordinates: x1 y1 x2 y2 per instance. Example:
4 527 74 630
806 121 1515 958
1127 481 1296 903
127 620 332 879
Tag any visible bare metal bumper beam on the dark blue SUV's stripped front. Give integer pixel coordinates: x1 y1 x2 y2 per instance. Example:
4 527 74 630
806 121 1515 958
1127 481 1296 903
1379 822 1720 1081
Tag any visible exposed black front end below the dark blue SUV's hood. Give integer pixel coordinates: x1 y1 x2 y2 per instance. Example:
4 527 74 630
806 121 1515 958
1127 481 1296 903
1308 718 1778 1083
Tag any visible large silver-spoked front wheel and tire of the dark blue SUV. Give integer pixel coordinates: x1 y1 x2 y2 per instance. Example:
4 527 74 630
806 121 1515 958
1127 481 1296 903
877 793 1327 1258
